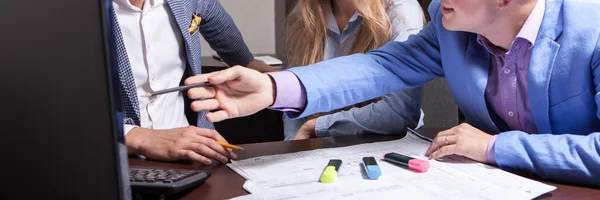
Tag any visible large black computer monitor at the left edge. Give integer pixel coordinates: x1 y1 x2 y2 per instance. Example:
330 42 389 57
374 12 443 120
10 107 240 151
0 0 130 200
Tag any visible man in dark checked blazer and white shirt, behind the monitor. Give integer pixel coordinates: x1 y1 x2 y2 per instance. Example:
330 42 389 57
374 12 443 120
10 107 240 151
110 0 273 165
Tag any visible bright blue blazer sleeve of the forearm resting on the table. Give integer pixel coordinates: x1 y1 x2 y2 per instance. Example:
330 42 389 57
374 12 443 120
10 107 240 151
493 34 600 186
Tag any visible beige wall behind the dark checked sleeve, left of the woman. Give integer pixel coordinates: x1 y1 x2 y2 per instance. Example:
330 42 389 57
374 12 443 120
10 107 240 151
201 0 275 56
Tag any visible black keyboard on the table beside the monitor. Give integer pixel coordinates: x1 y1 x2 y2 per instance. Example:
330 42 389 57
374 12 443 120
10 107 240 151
129 167 210 194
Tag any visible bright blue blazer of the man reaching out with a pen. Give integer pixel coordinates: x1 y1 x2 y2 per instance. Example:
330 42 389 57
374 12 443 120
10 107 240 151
288 0 600 186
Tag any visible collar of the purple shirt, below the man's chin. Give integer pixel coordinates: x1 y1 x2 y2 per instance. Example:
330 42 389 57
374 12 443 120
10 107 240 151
477 0 546 56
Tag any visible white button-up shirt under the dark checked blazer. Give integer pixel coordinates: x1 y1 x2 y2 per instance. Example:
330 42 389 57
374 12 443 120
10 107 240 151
113 0 189 134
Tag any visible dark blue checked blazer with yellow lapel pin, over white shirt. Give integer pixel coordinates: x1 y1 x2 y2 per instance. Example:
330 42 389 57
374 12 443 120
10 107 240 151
112 0 254 129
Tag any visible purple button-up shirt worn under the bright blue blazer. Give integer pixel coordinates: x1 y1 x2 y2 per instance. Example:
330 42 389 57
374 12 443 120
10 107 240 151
486 0 546 164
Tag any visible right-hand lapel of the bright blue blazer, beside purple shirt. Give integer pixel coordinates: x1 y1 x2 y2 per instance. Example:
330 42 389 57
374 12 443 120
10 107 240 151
527 0 563 133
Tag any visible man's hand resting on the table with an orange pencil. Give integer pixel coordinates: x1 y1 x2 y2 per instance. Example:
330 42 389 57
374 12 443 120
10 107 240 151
125 126 237 165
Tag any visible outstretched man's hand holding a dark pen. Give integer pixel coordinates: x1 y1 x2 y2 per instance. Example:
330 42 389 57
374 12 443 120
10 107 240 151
185 66 275 122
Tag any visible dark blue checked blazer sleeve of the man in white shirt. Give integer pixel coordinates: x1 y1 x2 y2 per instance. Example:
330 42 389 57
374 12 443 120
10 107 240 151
197 0 254 66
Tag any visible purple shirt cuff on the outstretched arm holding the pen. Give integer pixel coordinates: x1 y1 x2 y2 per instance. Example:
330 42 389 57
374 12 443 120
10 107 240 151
267 71 306 112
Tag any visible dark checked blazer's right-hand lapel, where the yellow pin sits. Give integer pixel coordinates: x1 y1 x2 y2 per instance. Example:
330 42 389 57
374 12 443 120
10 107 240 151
167 0 200 75
